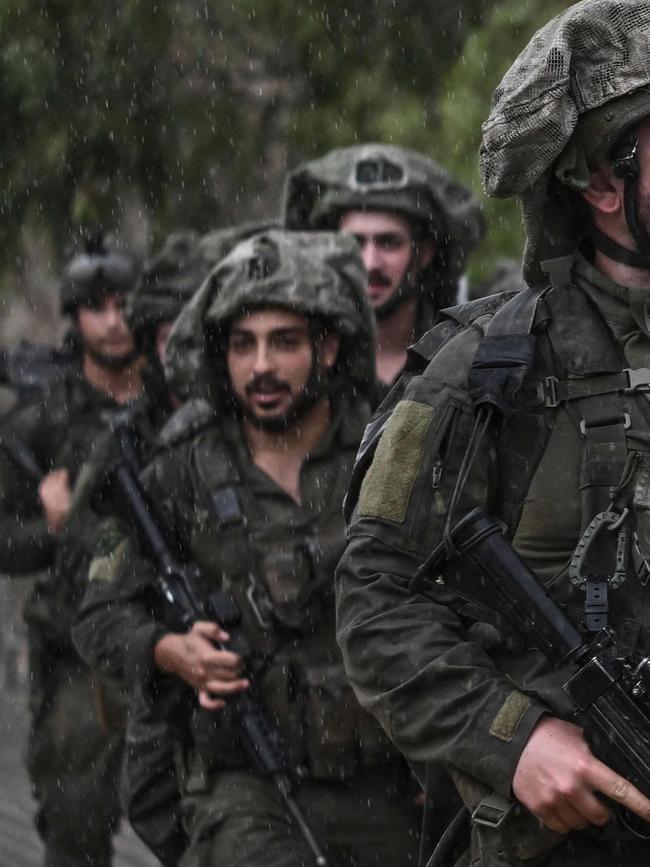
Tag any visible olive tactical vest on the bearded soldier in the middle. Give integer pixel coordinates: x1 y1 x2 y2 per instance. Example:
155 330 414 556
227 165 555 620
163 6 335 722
159 410 397 780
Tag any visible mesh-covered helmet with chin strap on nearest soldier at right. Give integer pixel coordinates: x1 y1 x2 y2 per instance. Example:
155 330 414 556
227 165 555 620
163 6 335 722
480 0 650 283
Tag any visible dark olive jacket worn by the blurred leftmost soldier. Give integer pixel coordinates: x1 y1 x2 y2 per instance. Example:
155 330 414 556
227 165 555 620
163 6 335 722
0 367 168 645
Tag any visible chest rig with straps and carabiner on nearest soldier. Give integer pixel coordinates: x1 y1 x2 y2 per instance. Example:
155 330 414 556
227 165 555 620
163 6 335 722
468 257 650 632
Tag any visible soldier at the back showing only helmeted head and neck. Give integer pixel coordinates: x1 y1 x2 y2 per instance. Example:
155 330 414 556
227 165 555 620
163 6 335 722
284 144 484 397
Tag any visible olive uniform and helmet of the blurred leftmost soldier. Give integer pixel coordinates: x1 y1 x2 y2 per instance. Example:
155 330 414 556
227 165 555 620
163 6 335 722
0 239 177 867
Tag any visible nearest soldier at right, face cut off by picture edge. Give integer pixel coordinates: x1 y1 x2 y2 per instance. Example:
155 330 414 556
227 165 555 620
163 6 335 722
337 0 650 867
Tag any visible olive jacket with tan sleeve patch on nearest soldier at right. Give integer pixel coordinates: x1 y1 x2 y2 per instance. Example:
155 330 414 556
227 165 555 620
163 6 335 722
337 262 650 863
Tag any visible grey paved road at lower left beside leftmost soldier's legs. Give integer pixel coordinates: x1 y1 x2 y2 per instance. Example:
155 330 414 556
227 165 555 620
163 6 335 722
0 579 159 867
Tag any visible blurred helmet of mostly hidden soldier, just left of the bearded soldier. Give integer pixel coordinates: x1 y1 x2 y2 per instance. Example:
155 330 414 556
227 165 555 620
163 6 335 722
126 231 209 344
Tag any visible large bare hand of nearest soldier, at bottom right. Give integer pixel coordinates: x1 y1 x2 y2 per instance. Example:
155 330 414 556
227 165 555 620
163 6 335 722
512 716 650 834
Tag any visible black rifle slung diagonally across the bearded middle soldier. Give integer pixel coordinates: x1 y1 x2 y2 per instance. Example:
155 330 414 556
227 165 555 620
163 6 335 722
111 426 327 867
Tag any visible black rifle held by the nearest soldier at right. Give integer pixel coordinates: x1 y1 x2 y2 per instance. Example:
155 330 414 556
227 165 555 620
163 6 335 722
411 509 650 839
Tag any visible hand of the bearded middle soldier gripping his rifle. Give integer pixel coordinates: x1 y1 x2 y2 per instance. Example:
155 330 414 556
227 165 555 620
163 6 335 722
154 620 249 710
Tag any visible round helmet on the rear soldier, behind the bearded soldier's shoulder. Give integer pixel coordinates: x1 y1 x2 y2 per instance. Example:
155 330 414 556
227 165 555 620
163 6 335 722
283 144 484 275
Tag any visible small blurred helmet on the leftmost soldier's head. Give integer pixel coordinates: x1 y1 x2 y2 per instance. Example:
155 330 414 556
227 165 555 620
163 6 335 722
59 237 137 316
